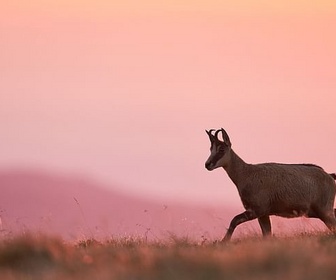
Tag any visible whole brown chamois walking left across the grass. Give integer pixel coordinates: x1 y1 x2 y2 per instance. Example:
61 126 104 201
205 128 336 241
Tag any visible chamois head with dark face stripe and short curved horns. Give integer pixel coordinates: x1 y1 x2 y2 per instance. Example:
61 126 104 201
205 128 231 171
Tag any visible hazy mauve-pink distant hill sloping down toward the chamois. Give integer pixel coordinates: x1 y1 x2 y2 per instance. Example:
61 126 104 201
0 170 233 238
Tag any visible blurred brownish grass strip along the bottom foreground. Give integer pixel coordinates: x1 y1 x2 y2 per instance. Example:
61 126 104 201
0 233 336 280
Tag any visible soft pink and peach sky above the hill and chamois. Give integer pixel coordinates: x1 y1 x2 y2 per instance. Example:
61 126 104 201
0 0 336 205
